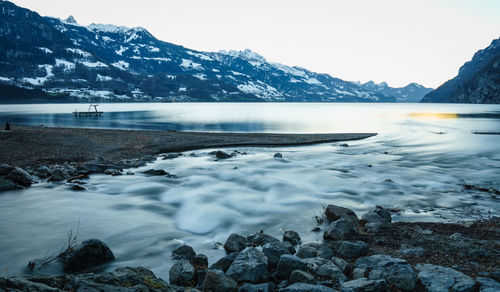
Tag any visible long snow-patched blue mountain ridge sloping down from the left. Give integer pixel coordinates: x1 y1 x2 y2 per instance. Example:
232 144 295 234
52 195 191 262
0 1 426 102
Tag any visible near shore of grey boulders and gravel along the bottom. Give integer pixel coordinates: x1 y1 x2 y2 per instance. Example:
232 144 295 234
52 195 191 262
0 205 500 292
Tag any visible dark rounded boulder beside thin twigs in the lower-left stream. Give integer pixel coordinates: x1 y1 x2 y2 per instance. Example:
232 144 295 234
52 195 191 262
60 239 115 272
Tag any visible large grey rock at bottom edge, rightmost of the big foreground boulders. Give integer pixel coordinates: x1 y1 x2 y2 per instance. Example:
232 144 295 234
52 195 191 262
415 264 475 292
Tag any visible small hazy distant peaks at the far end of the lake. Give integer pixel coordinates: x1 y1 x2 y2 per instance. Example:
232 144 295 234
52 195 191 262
361 81 432 102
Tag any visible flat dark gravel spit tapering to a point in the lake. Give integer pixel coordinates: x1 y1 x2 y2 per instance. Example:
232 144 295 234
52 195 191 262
0 125 376 167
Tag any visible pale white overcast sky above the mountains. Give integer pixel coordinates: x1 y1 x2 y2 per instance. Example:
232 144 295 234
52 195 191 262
8 0 500 87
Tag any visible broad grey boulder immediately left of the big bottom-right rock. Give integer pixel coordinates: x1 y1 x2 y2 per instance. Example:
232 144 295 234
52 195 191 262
353 254 417 290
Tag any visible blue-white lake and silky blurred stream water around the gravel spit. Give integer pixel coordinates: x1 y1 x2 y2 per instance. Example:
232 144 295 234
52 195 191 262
0 104 500 278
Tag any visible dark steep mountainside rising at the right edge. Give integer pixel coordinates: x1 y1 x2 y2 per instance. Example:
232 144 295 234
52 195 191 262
422 38 500 103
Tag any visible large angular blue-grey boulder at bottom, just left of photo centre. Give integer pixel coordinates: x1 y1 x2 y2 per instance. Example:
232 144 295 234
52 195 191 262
226 247 268 283
